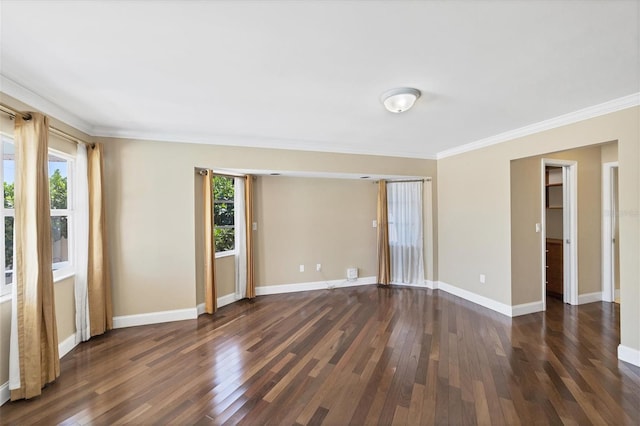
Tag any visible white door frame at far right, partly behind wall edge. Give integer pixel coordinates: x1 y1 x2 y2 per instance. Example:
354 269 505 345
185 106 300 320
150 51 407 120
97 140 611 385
602 161 620 302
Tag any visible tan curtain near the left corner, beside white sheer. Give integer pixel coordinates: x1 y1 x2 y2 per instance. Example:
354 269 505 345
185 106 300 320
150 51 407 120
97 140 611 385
87 143 113 336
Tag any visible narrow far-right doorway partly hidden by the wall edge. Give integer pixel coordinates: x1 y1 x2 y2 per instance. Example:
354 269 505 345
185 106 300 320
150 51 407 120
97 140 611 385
602 161 620 303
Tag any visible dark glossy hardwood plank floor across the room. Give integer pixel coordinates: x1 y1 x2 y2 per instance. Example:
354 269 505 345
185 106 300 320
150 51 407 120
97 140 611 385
0 286 640 425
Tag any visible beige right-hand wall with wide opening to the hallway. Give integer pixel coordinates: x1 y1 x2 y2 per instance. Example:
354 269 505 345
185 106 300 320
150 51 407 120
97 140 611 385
438 107 640 350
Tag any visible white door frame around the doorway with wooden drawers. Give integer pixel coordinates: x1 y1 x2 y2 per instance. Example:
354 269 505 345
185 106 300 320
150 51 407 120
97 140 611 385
540 158 578 310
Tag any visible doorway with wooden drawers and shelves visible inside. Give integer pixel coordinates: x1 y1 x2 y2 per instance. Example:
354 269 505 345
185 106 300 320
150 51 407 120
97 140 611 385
542 159 578 309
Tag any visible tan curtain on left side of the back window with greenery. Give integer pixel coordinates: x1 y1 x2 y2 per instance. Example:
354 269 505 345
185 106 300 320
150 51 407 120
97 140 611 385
201 170 217 314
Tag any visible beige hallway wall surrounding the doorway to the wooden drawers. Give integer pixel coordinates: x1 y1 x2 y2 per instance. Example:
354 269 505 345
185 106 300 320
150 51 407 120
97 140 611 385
511 146 602 305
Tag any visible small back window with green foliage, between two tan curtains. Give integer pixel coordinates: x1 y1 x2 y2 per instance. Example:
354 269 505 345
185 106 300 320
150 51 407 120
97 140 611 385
212 176 235 253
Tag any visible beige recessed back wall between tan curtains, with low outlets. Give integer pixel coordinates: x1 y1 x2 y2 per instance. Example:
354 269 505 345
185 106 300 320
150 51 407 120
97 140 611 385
255 176 377 286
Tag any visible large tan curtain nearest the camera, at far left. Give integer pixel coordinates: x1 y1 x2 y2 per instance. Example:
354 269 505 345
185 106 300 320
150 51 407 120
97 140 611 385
9 113 60 400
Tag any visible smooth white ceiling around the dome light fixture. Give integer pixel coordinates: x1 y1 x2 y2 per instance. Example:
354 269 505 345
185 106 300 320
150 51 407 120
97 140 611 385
0 0 640 158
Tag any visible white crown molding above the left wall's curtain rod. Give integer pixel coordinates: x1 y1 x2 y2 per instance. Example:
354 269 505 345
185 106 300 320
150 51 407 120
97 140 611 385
0 74 93 136
